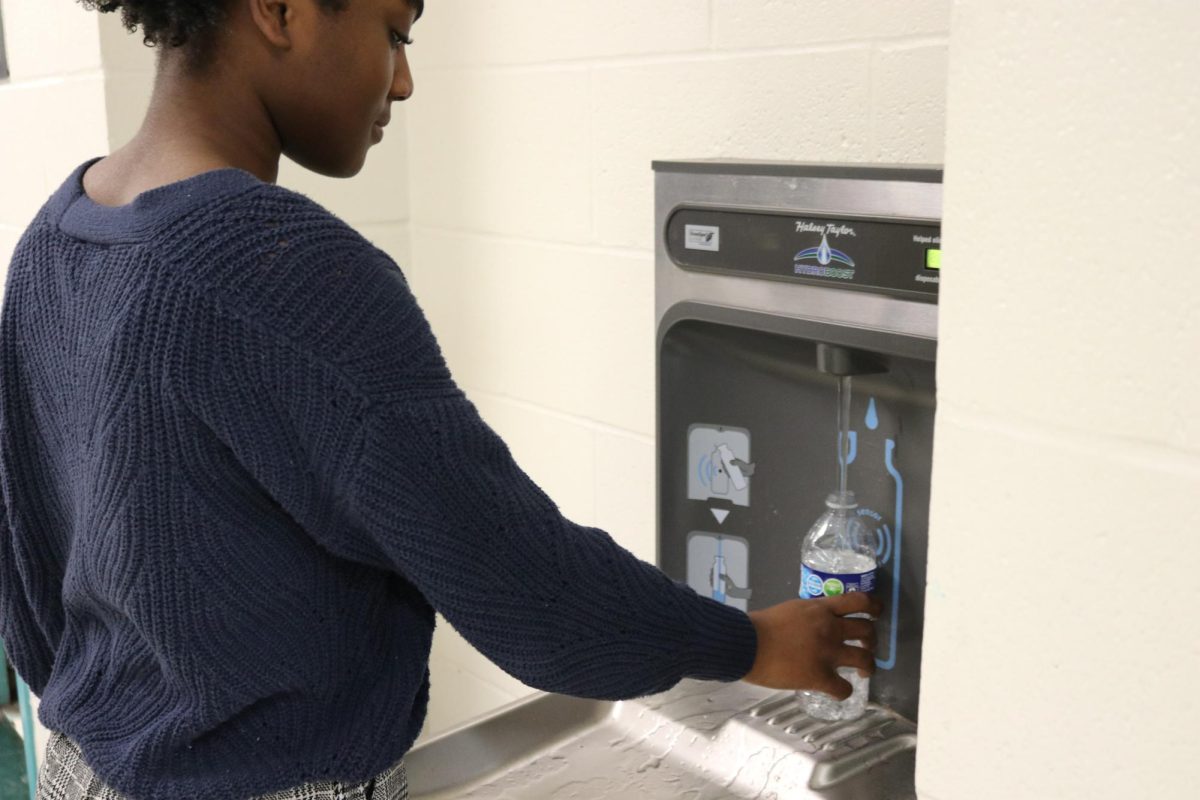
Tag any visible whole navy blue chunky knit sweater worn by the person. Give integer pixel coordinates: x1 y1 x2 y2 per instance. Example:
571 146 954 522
0 160 756 800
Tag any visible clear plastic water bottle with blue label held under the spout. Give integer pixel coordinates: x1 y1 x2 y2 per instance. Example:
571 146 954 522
797 491 876 720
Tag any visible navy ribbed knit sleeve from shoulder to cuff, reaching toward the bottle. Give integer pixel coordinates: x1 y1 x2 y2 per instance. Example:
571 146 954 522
147 190 757 699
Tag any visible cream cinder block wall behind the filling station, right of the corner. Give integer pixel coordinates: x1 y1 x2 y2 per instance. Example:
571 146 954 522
407 0 950 738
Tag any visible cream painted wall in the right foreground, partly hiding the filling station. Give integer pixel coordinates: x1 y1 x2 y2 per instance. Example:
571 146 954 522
918 0 1200 800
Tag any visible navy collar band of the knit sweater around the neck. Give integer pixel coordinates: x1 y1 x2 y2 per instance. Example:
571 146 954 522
49 156 263 245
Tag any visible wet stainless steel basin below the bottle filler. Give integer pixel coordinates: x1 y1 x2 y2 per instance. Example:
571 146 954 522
404 680 917 800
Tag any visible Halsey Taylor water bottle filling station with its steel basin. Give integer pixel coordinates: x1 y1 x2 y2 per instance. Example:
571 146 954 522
407 161 942 800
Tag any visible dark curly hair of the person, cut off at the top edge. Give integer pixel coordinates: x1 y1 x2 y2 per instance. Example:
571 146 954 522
78 0 425 71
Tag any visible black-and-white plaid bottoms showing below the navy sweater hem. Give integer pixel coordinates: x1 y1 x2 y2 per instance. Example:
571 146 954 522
37 732 408 800
